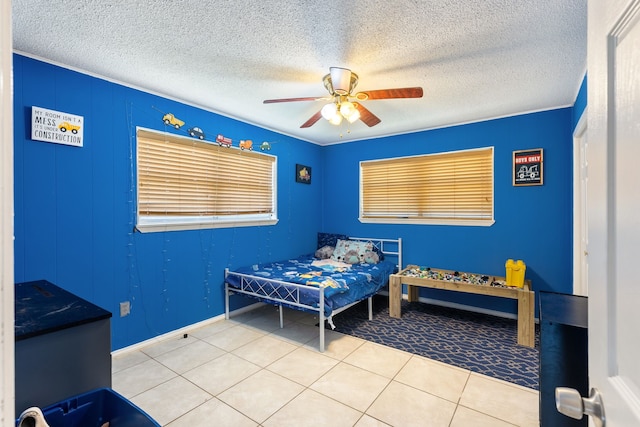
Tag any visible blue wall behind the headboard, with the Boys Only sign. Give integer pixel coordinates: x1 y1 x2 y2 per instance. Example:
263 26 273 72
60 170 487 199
322 108 573 313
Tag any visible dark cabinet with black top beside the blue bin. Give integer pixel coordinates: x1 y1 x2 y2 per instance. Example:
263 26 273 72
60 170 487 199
15 280 111 414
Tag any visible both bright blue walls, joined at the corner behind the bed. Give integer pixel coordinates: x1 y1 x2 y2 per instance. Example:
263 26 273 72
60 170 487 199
14 55 574 349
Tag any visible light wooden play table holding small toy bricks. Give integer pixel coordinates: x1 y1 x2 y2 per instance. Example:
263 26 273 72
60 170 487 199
389 265 535 347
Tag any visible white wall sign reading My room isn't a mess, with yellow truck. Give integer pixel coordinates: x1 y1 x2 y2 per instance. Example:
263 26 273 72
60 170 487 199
31 106 84 147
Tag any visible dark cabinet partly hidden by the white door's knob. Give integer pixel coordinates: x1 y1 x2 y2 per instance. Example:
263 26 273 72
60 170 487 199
538 291 589 427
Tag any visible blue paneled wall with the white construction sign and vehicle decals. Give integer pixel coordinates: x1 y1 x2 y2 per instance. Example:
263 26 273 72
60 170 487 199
14 55 321 349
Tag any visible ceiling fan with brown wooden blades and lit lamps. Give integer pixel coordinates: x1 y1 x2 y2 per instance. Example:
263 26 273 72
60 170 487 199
263 67 423 128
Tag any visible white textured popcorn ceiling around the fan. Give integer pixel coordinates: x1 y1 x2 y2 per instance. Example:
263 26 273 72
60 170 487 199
13 0 587 145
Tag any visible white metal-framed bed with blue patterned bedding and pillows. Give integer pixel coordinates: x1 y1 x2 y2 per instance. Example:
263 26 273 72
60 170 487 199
224 233 402 352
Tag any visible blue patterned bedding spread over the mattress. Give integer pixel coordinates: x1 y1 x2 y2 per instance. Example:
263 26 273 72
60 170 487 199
225 254 396 316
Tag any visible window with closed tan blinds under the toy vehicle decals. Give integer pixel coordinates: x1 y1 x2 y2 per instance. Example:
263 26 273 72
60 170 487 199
136 128 277 232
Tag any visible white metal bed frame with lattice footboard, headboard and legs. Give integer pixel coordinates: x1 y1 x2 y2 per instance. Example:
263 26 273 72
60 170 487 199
224 237 402 352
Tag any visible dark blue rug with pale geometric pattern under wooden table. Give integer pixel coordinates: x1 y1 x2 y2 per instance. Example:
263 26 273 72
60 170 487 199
334 295 540 390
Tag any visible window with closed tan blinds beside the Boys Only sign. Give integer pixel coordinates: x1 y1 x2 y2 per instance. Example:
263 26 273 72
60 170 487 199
360 147 493 226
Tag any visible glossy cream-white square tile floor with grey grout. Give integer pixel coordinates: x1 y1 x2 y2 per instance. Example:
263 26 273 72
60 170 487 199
113 306 539 427
